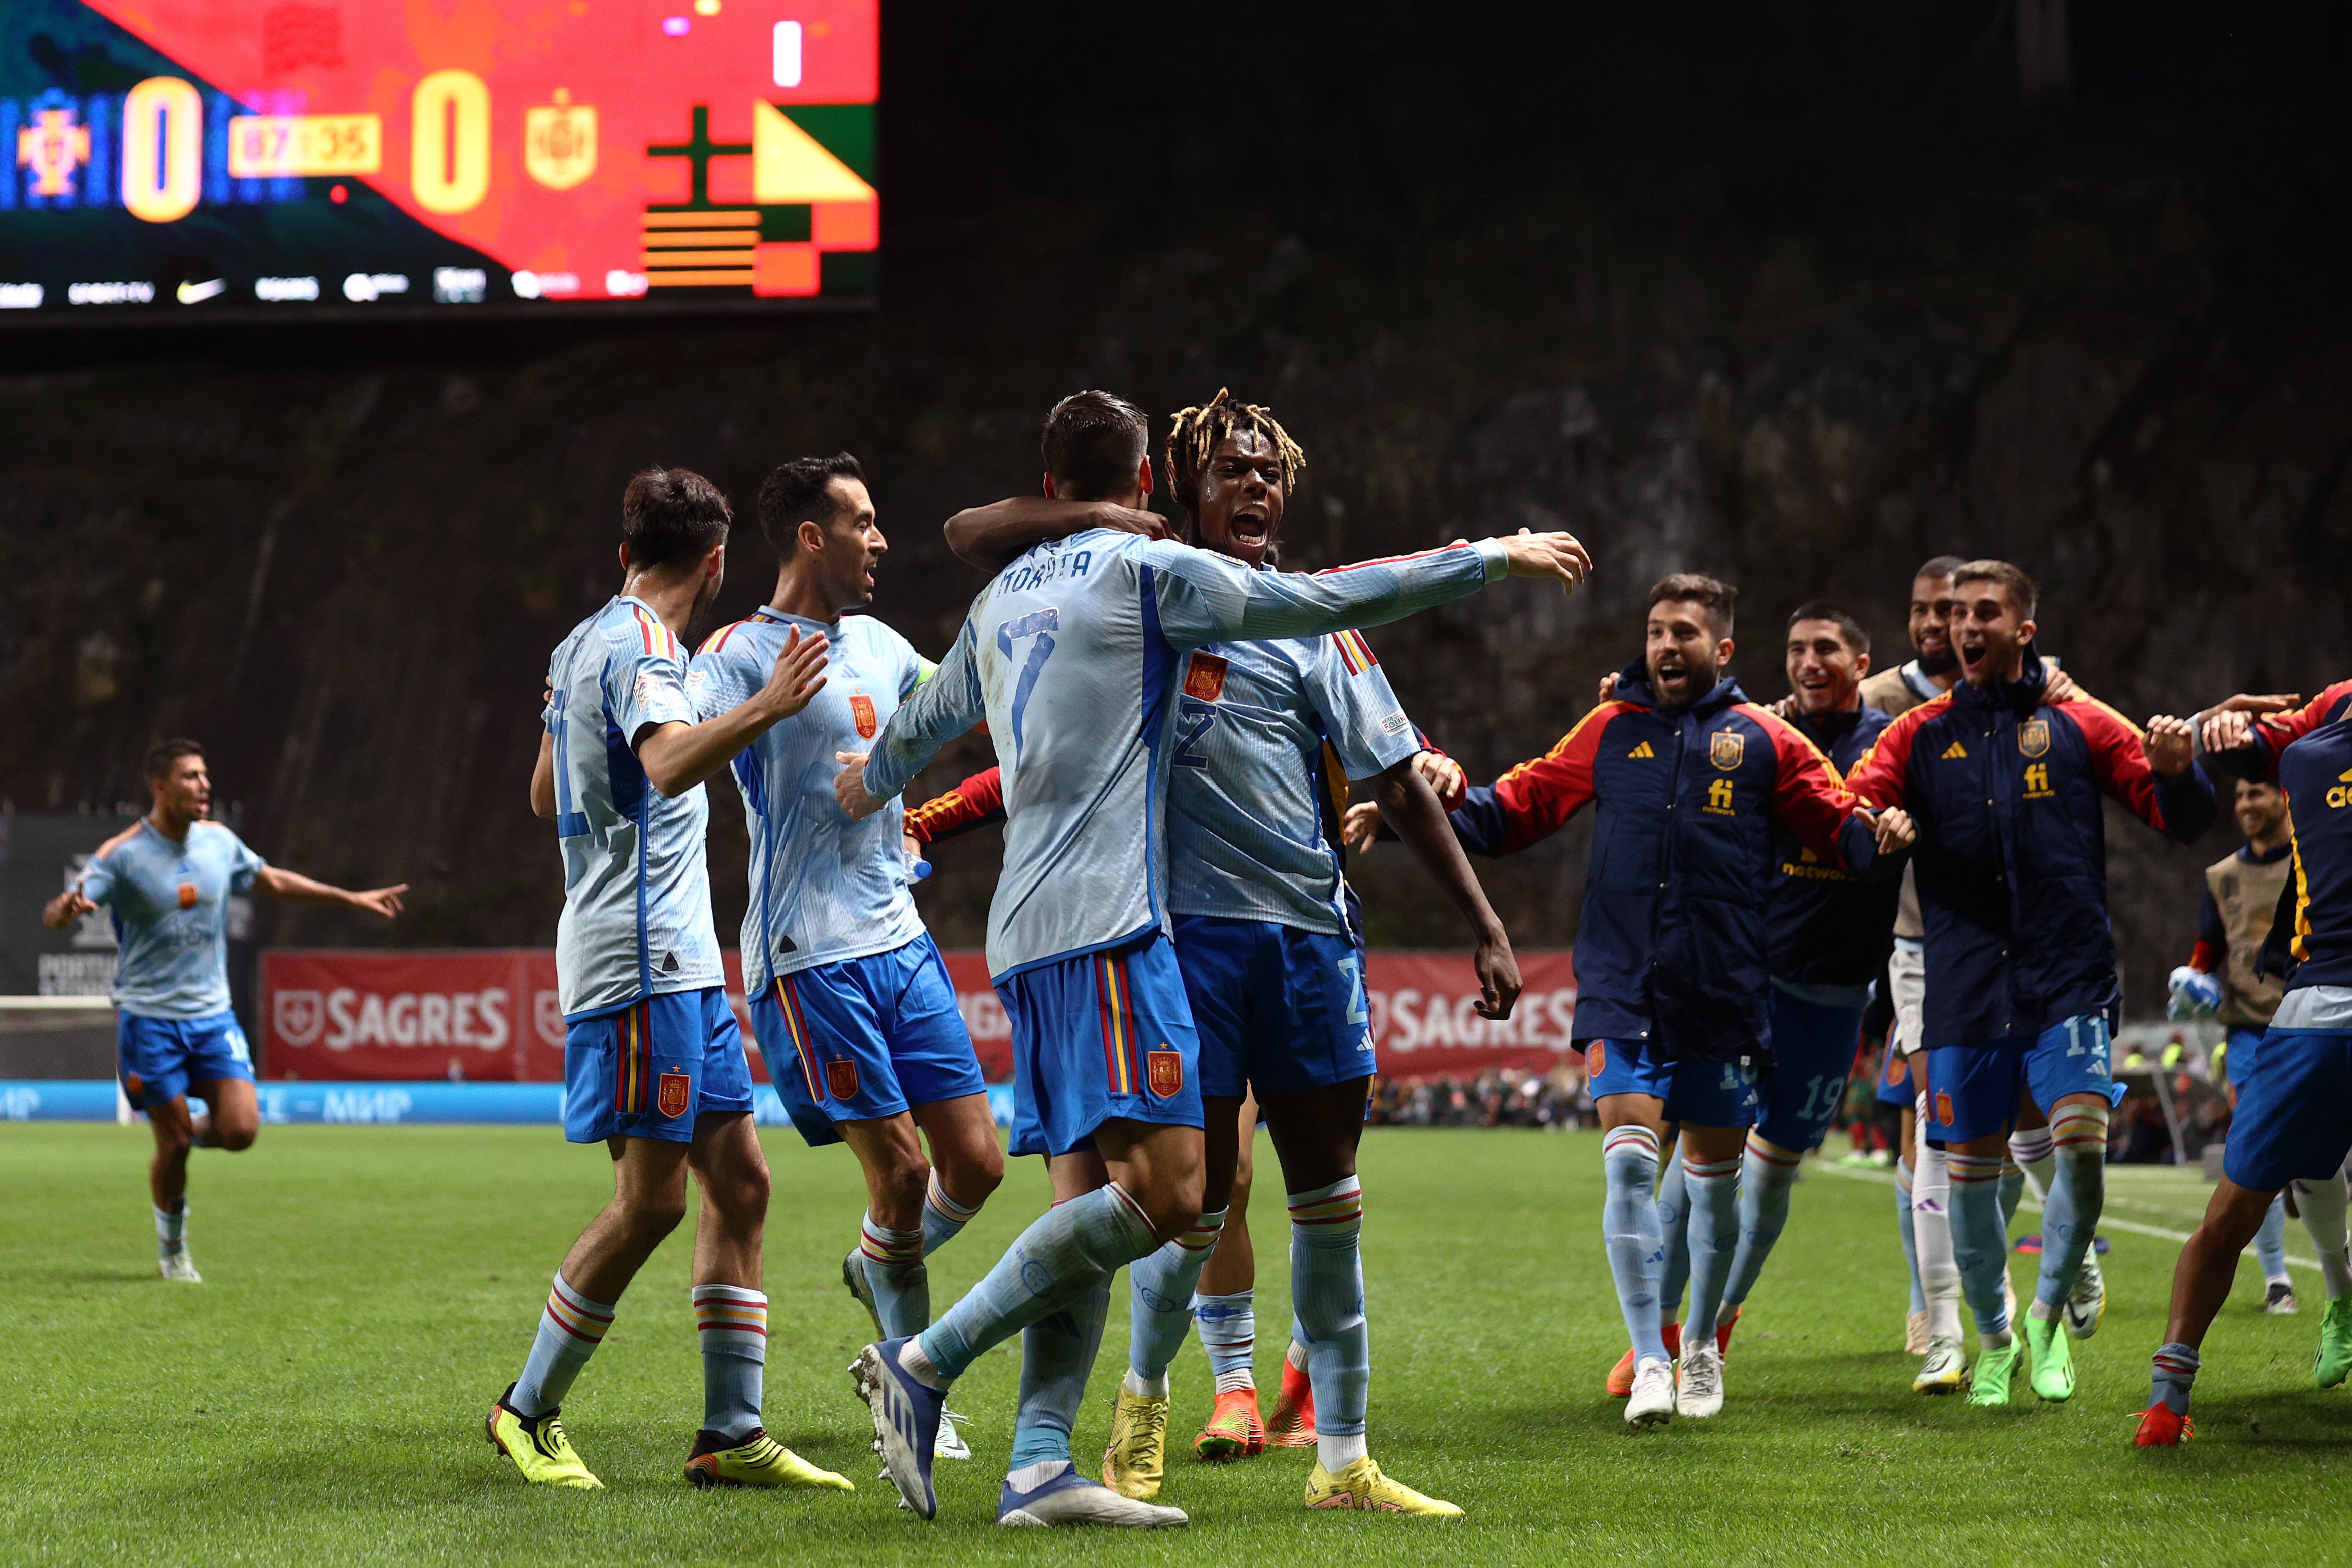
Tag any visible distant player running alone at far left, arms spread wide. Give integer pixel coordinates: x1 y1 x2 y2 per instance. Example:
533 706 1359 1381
40 740 409 1286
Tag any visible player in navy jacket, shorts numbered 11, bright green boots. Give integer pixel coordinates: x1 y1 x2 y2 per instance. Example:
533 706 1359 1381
1846 562 2216 1404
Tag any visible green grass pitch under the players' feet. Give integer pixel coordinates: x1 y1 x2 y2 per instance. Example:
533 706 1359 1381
0 1126 2352 1565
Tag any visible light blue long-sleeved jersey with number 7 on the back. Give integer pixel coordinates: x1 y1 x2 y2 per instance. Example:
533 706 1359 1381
865 529 1508 981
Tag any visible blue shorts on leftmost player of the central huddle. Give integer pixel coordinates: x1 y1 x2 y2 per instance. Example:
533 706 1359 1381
564 985 750 1142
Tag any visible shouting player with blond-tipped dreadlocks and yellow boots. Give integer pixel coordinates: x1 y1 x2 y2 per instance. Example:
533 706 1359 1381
936 390 1519 1514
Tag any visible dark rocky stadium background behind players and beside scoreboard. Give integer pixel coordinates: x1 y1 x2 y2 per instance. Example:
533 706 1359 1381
0 0 2352 1016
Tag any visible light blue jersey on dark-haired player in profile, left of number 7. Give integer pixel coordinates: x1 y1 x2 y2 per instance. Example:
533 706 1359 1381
687 607 922 992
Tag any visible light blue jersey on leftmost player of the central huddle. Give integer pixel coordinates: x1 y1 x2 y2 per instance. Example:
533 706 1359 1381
546 597 727 1020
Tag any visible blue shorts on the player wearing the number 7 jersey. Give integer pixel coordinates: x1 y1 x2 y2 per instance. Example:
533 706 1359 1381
997 931 1202 1154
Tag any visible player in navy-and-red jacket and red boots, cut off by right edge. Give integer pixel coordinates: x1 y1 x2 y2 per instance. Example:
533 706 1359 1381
2135 682 2352 1448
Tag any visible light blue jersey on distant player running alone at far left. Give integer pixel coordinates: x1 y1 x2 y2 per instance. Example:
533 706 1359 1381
80 821 268 1018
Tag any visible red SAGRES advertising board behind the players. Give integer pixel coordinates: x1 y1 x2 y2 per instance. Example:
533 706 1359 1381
261 947 1576 1084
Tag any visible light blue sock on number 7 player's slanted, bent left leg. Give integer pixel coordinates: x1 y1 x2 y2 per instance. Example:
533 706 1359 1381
917 1183 1159 1385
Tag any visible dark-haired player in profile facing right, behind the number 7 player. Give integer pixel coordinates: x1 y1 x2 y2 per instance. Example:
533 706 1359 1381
687 451 1004 1457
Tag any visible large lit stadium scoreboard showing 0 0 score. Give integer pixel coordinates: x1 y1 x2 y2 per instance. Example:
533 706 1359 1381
0 0 879 327
